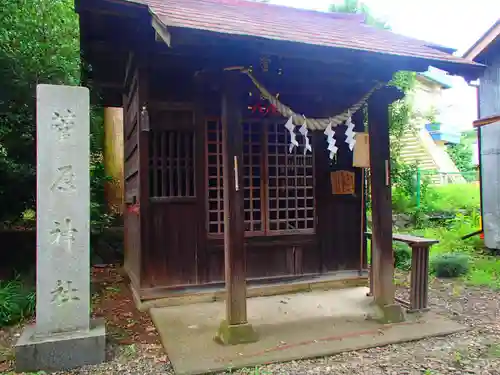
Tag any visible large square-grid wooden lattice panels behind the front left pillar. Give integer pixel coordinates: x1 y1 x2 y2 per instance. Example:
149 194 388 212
206 120 315 235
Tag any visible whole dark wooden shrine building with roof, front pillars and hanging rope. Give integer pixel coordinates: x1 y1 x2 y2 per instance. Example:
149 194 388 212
76 0 482 344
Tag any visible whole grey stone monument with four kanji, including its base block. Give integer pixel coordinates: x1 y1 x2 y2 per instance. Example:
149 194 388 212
15 85 106 372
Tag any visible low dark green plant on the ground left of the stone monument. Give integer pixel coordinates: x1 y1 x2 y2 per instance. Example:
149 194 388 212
0 279 35 327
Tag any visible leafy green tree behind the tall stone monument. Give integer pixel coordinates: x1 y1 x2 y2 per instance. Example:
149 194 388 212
0 0 80 222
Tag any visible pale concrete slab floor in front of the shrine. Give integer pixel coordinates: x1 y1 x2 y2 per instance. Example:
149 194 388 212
150 288 465 375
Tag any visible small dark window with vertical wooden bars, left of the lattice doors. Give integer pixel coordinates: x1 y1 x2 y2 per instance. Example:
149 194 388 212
149 130 196 198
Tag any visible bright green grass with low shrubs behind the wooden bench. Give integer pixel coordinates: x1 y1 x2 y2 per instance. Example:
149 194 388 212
393 184 500 289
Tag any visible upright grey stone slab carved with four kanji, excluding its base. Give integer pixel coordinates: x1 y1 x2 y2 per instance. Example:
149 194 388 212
36 85 90 335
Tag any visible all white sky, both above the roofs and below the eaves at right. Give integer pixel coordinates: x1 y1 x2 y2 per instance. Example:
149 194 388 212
271 0 500 130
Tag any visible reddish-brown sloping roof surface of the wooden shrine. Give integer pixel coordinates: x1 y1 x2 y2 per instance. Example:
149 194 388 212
134 0 480 71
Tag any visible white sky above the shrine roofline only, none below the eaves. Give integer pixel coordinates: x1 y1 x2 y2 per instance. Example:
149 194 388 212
271 0 500 52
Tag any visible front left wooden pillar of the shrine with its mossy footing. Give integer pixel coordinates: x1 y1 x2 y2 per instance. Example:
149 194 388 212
217 72 256 345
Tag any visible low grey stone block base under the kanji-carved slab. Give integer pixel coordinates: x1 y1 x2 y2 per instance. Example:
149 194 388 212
15 319 106 372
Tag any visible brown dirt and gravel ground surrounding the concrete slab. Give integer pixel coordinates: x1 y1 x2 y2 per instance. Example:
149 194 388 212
0 267 500 375
